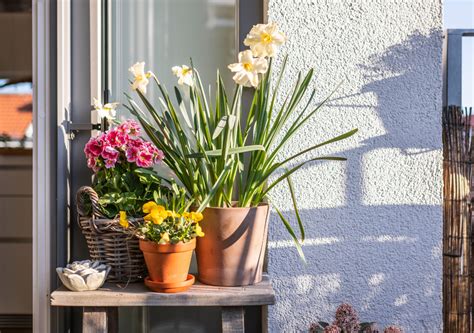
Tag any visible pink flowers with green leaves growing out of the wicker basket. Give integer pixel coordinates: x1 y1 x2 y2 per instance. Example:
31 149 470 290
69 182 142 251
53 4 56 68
84 120 167 218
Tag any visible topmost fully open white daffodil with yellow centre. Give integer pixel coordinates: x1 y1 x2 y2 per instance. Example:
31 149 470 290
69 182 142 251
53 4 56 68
244 23 286 57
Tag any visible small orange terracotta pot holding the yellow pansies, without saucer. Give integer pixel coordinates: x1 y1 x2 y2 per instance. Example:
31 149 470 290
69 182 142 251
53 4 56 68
140 239 196 283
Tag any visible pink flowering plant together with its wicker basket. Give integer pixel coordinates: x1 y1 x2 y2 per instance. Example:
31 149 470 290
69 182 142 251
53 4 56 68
76 118 169 283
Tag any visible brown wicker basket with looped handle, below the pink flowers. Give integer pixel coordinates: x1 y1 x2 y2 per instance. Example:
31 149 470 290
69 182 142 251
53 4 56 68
76 186 146 283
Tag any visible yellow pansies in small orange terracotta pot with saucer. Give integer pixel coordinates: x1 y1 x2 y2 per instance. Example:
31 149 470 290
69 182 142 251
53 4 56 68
124 184 204 293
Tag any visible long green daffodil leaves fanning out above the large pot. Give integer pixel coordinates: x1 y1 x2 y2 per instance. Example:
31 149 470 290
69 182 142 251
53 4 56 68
126 58 357 257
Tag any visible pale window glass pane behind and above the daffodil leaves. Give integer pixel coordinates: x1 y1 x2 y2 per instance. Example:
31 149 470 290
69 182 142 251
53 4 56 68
109 0 236 115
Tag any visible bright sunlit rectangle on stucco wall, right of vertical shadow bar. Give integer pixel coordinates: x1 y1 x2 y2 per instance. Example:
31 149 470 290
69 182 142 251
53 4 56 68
363 148 442 206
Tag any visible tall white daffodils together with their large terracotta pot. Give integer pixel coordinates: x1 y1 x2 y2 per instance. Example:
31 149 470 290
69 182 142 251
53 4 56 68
126 23 357 286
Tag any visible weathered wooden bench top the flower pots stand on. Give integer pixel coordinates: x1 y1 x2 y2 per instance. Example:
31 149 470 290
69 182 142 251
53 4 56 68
51 275 275 307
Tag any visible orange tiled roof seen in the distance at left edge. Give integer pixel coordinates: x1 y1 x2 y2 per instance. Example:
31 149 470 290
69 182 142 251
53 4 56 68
0 94 33 139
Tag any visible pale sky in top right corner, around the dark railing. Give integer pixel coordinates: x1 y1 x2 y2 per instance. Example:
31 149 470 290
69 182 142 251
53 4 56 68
443 0 474 107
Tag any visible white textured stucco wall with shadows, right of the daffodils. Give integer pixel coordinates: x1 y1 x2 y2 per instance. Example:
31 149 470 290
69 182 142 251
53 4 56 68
268 0 442 332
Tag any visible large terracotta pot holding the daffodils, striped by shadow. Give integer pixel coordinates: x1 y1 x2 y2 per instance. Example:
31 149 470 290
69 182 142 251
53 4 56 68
196 204 268 286
